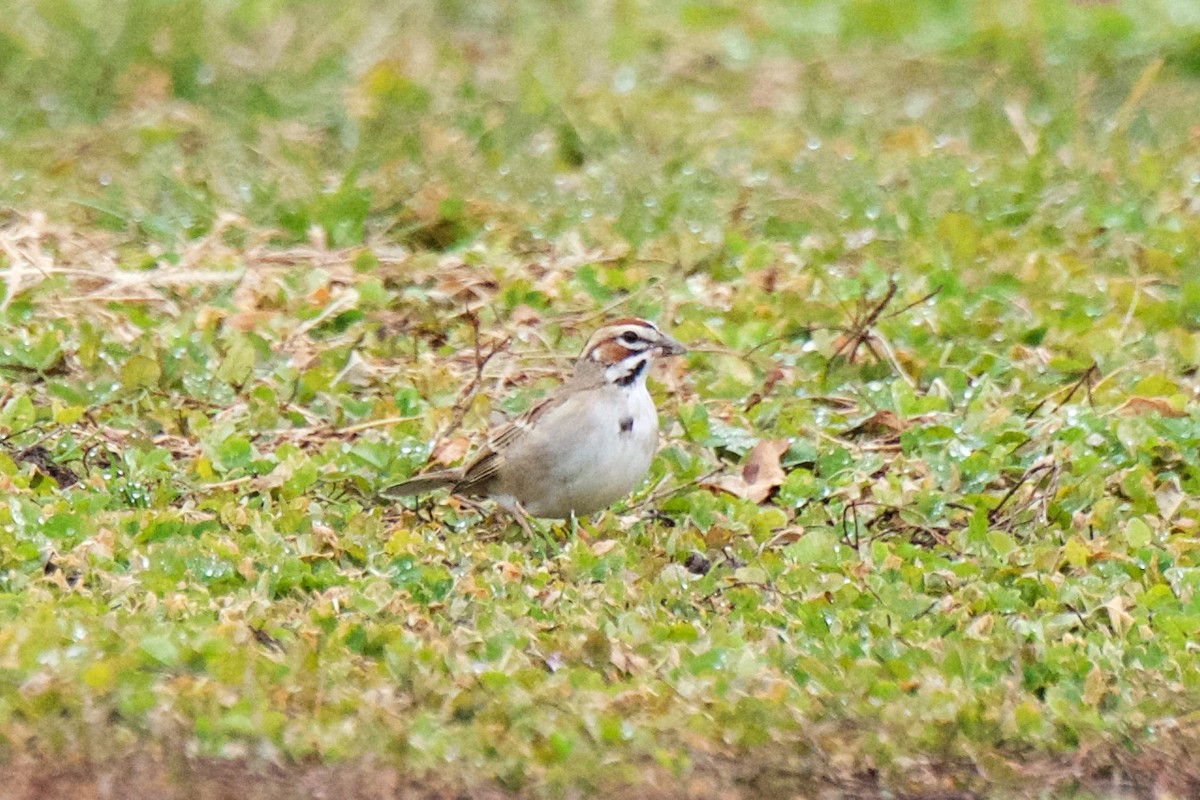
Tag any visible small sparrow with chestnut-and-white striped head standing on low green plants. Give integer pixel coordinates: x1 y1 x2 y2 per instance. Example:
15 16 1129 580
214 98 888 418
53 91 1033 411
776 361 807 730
385 319 685 527
